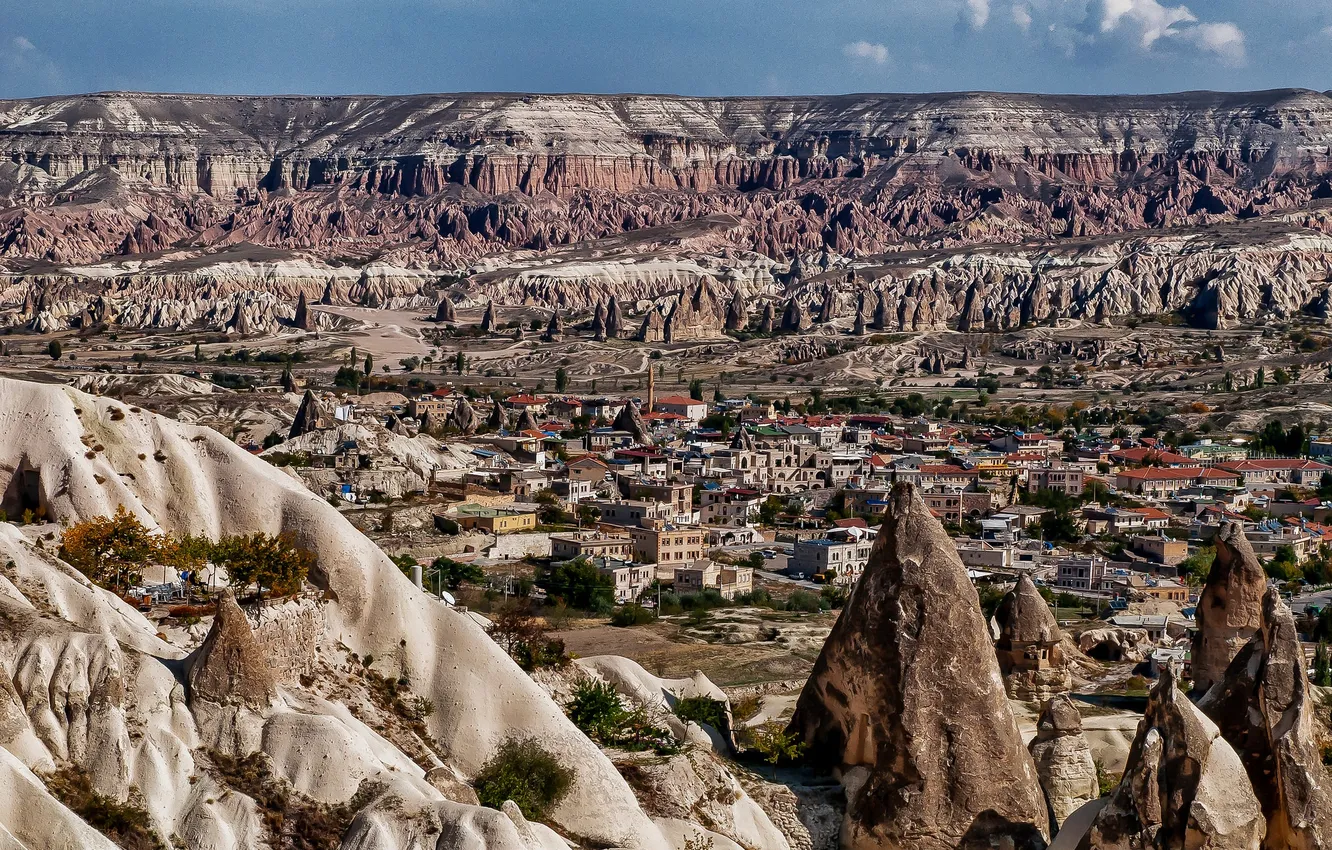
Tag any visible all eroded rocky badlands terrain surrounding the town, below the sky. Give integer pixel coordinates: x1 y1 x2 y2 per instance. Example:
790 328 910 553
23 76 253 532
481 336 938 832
0 83 1332 850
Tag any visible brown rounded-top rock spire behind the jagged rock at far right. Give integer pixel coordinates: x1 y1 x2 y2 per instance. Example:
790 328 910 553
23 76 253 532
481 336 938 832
1192 522 1267 694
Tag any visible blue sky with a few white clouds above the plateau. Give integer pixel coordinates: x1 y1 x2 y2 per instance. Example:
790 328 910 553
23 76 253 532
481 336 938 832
0 0 1332 97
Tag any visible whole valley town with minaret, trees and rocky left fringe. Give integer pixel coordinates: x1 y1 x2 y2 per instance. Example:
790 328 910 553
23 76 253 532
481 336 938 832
264 372 1332 687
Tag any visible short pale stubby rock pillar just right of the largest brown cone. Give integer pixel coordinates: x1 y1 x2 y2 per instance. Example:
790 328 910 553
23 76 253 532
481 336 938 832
1027 694 1100 830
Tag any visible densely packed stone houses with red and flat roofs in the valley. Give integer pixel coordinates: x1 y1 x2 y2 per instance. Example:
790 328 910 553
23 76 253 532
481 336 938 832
283 390 1332 618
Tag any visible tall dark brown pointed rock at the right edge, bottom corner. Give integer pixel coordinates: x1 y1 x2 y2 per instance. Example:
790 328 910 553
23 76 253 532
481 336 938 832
1199 589 1332 850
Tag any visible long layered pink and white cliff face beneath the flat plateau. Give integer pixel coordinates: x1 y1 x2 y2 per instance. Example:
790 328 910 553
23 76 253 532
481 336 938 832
0 91 1332 334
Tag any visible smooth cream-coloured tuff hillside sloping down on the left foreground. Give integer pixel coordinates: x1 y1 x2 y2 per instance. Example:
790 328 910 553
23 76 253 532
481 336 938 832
0 380 670 850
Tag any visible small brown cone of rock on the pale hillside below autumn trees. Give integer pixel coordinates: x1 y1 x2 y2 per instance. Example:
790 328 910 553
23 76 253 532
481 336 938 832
185 590 277 711
